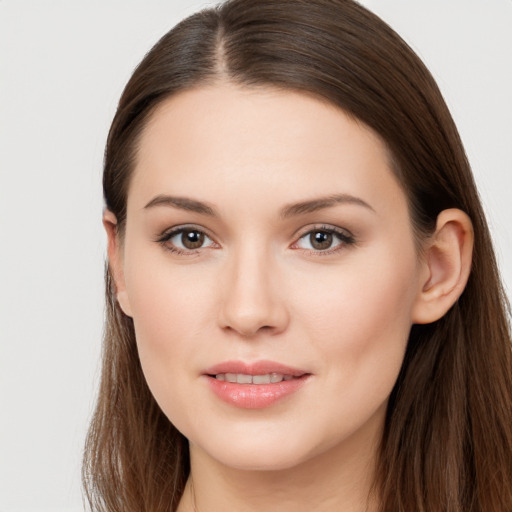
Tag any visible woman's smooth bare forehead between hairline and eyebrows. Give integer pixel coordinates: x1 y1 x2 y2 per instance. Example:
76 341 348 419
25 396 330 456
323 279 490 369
129 83 403 216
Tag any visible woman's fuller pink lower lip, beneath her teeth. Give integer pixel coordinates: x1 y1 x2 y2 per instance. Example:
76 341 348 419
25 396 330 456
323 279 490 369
207 375 309 409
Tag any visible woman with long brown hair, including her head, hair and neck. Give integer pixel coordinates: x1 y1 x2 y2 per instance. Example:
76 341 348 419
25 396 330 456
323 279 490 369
84 0 512 512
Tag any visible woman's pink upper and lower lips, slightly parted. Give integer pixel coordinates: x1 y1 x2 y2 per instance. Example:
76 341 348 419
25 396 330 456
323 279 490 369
203 361 311 409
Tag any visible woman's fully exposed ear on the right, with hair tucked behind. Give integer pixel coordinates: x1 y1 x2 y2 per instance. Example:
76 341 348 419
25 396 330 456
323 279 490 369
412 209 474 324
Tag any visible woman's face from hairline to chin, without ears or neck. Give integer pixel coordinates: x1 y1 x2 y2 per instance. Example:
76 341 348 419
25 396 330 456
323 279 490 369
113 84 424 469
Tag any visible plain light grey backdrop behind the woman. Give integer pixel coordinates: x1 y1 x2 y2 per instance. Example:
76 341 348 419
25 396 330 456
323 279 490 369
0 0 512 512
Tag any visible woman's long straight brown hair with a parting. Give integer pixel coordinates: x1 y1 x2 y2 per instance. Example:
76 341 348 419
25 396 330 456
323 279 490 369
83 0 512 512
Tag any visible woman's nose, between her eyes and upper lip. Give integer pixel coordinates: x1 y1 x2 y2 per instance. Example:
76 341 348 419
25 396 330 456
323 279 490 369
219 246 289 337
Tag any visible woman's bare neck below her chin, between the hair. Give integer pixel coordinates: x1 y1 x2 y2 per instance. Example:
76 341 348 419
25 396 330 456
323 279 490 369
178 412 381 512
